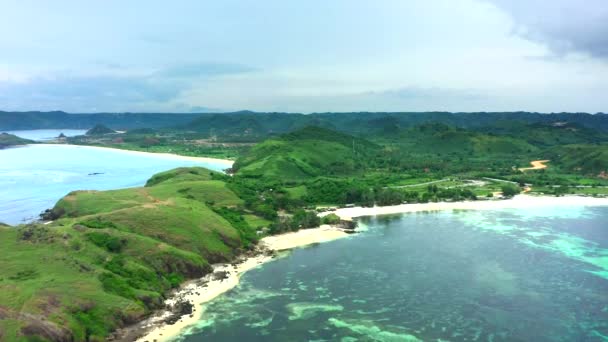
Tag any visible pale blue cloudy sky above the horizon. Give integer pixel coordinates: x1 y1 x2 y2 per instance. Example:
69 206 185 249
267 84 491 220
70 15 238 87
0 0 608 113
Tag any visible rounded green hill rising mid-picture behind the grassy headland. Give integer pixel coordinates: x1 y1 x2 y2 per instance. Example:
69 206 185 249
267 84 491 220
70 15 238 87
233 126 379 181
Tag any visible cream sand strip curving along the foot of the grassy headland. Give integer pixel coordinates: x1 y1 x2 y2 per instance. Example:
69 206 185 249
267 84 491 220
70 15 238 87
137 225 349 342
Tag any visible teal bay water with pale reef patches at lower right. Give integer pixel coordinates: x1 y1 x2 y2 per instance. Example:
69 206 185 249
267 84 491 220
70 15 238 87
180 207 608 342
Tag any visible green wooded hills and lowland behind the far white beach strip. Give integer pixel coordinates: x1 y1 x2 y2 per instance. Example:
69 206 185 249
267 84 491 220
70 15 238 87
226 123 608 210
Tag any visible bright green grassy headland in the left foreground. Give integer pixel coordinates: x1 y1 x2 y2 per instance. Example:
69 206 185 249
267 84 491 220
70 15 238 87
0 168 267 341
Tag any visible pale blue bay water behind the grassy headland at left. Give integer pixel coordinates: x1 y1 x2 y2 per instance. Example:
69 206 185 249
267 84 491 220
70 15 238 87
0 145 226 224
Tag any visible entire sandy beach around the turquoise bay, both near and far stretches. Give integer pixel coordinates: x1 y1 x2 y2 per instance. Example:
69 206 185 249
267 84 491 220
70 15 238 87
131 195 608 342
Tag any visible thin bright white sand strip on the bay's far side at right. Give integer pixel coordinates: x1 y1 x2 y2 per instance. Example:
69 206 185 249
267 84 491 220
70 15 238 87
320 195 608 220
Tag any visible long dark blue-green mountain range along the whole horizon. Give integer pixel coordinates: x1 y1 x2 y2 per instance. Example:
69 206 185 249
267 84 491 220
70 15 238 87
0 111 608 137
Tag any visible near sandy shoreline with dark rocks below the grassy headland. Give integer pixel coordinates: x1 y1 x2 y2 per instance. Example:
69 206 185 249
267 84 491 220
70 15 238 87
132 225 350 342
